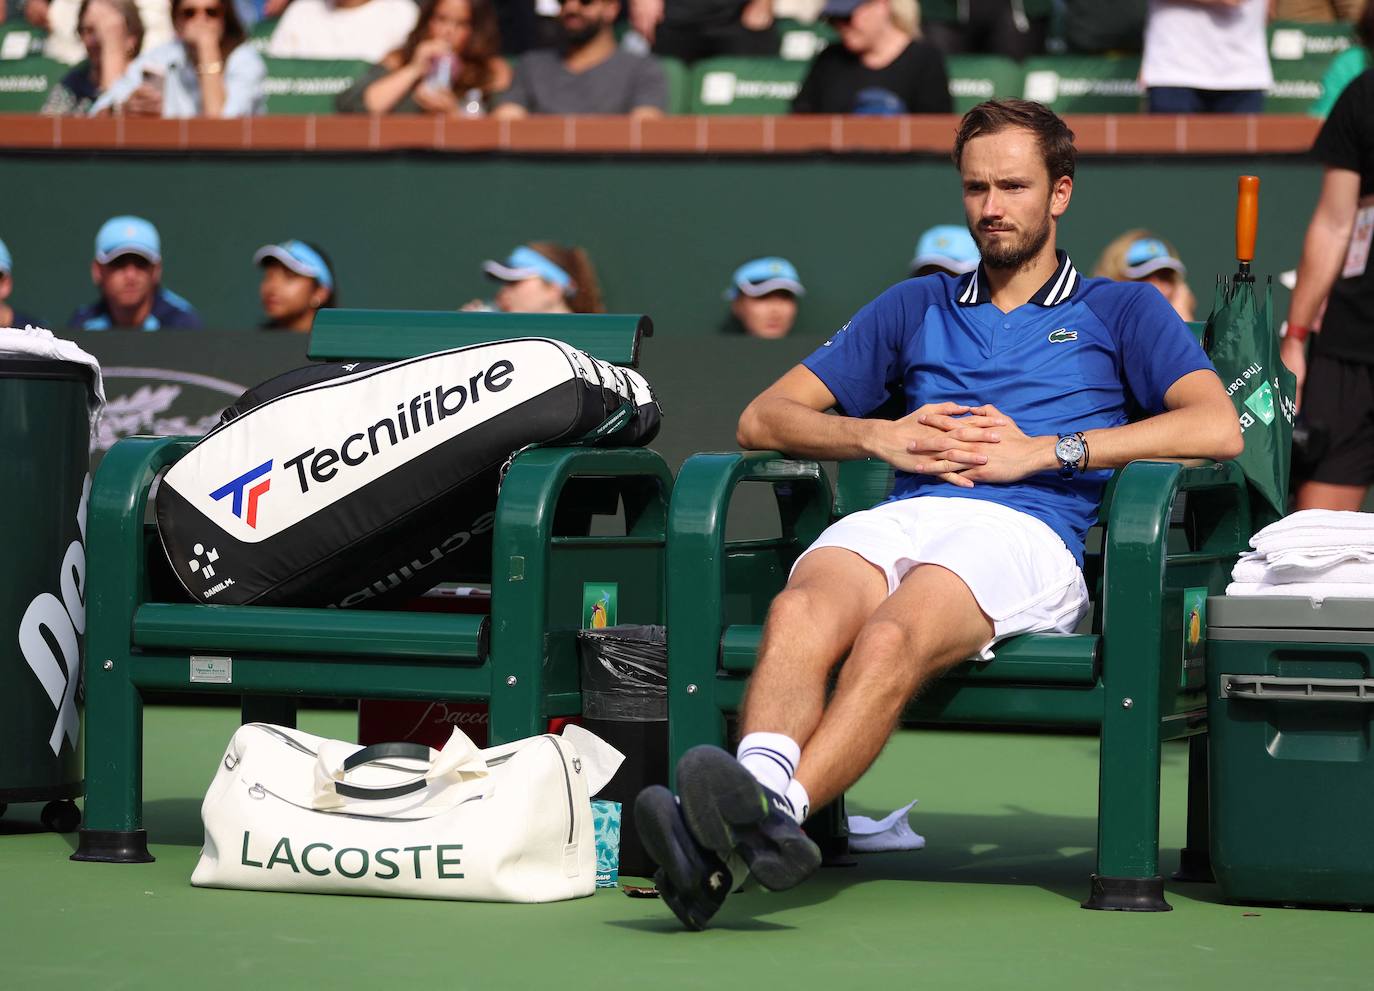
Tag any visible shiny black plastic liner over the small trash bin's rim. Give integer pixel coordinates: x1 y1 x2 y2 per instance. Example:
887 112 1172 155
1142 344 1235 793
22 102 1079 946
577 624 668 723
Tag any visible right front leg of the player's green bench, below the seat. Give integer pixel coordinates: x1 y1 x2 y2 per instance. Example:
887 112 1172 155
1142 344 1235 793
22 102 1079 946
1083 700 1172 911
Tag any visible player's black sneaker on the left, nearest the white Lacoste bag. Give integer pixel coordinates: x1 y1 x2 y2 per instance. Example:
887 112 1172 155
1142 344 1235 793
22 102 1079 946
635 785 735 931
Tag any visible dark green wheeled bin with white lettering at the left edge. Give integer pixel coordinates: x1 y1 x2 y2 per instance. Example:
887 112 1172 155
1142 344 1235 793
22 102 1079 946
0 356 91 832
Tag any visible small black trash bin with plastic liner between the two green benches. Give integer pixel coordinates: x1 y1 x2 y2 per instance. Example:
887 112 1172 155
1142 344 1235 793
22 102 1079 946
577 625 668 877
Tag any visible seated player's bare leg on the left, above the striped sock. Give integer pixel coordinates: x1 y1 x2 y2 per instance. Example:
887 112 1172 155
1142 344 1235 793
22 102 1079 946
741 547 888 744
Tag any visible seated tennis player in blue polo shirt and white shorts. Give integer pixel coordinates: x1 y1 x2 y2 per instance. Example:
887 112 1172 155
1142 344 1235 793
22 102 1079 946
635 100 1242 929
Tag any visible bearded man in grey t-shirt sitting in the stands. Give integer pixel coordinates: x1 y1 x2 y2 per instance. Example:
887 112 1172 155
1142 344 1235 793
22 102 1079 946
491 0 668 118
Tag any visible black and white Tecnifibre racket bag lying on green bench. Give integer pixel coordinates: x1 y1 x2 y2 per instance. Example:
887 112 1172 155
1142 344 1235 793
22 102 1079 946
157 338 660 608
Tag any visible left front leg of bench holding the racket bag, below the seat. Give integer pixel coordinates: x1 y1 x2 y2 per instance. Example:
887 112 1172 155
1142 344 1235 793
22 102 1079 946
71 658 154 863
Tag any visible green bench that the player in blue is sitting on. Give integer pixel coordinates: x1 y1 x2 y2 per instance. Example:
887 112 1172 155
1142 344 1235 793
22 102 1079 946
668 324 1268 910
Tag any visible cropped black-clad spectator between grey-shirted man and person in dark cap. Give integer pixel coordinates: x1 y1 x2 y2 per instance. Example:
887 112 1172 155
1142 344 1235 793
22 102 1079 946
629 0 782 62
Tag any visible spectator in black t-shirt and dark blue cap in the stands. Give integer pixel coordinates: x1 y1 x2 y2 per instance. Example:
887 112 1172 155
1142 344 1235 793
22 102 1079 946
791 0 954 114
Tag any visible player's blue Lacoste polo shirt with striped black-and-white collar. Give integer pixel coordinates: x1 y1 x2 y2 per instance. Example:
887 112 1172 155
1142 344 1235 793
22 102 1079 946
802 252 1212 565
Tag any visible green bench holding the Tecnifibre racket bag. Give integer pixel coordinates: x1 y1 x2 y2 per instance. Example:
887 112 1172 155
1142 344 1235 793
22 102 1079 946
73 309 672 863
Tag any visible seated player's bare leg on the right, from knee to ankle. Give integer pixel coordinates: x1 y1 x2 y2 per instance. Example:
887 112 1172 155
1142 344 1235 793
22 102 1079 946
791 565 992 808
